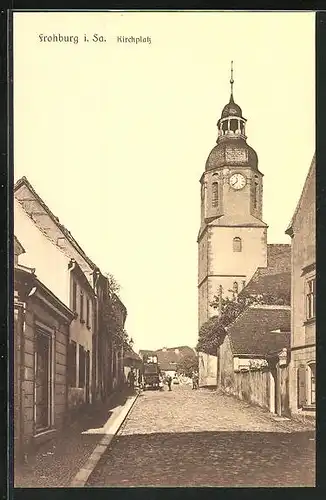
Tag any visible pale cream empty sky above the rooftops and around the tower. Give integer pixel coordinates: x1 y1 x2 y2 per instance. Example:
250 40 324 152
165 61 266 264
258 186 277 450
14 12 315 350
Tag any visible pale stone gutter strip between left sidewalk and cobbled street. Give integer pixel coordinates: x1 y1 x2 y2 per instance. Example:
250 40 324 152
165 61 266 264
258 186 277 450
69 393 139 488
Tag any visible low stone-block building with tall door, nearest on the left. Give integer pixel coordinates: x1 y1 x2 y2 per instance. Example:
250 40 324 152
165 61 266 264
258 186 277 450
13 238 74 460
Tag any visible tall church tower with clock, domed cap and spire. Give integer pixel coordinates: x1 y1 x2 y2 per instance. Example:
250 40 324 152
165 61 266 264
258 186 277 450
197 63 267 327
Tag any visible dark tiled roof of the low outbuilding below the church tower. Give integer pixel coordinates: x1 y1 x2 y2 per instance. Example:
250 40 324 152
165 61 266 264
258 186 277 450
227 306 291 357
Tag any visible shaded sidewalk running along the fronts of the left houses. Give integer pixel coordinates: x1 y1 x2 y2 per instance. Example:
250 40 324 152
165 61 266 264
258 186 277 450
14 390 136 488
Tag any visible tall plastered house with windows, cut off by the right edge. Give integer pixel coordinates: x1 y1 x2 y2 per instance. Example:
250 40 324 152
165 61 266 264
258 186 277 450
286 157 316 416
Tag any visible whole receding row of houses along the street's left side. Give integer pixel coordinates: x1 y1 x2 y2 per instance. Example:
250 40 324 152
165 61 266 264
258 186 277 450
13 177 127 459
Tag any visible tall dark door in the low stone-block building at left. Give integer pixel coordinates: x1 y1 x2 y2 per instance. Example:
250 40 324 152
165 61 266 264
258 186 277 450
35 332 51 433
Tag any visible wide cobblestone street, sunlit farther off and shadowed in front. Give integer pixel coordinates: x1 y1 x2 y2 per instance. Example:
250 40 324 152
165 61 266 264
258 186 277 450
88 386 315 487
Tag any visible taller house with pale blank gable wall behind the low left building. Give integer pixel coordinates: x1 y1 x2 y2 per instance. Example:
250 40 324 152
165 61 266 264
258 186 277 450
14 177 126 408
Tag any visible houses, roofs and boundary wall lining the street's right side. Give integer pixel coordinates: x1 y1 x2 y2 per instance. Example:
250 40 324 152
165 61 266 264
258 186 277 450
199 157 316 418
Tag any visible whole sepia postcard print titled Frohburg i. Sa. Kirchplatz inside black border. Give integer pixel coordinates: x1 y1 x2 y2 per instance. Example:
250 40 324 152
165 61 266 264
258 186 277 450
12 10 316 488
